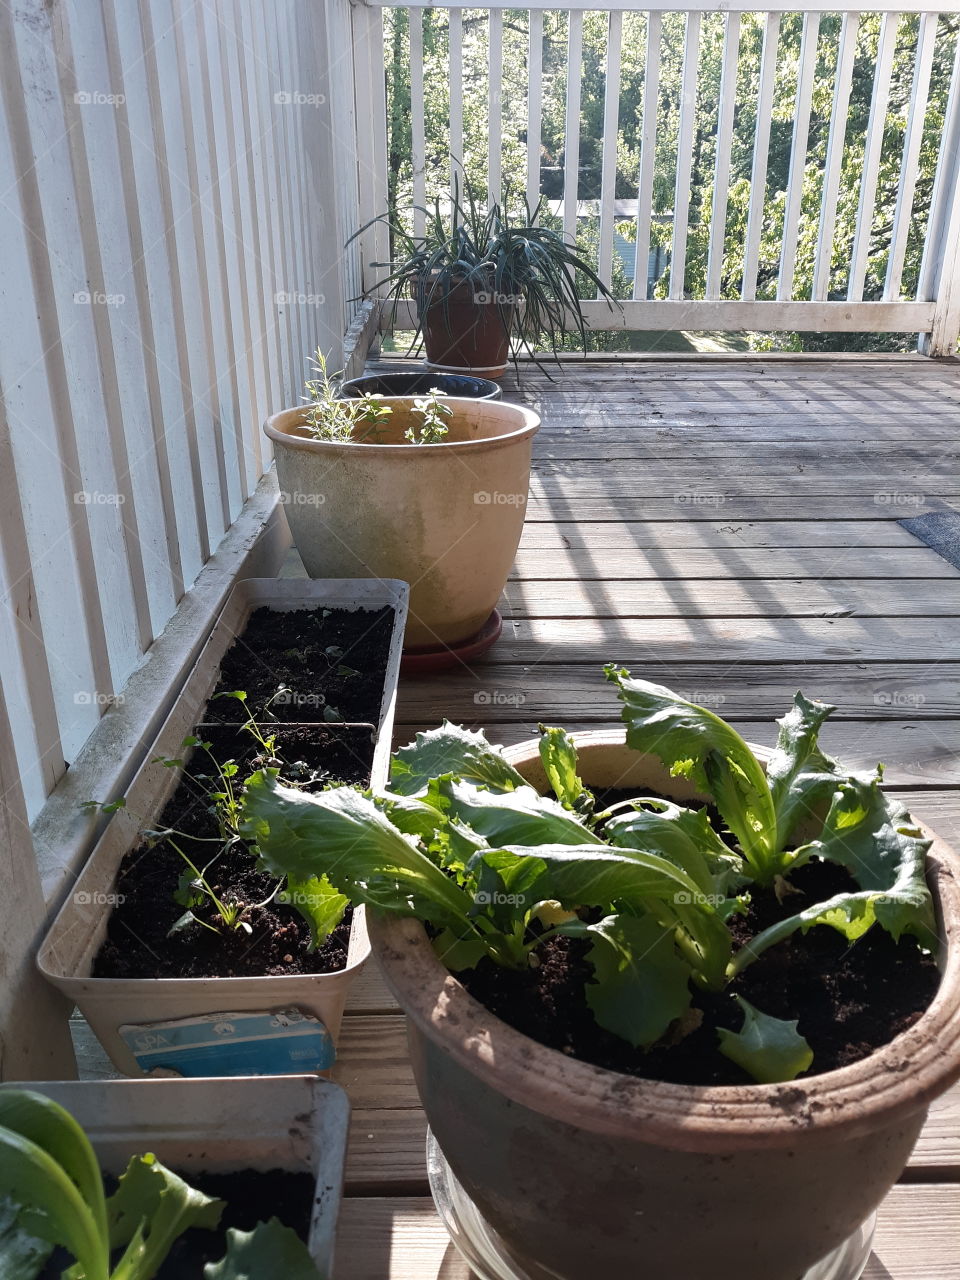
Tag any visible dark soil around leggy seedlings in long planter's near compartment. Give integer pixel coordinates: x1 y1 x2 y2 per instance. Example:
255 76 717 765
93 724 374 978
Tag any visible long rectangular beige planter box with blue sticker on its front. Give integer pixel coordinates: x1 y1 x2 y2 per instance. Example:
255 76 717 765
37 579 408 1075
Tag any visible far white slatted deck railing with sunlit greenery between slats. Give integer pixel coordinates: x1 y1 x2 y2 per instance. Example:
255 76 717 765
355 0 960 355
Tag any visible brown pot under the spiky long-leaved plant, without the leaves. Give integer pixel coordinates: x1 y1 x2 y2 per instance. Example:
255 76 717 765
416 284 516 378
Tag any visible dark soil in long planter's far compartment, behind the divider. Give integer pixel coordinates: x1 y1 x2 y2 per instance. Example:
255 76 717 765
206 605 393 724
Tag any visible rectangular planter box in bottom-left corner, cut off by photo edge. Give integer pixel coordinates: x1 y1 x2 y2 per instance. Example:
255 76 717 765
0 1075 349 1276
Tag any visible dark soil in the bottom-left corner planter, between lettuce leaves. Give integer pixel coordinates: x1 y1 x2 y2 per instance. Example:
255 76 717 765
37 1169 316 1280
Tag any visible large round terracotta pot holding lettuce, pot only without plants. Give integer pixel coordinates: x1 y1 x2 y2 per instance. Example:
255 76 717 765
371 730 960 1280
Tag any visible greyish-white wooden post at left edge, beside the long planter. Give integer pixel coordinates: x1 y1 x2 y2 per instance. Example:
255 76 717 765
0 689 77 1080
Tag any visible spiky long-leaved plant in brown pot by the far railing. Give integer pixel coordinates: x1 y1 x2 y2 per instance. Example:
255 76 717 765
357 177 613 378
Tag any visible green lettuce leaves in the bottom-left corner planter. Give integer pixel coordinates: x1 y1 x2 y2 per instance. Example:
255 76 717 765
0 1089 321 1280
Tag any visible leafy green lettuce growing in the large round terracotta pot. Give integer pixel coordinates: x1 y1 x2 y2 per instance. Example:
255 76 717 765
243 667 936 1083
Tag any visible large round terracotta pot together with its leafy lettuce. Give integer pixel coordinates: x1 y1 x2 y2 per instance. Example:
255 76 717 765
244 667 960 1280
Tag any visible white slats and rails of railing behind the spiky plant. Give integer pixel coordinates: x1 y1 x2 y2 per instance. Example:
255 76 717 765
353 0 960 355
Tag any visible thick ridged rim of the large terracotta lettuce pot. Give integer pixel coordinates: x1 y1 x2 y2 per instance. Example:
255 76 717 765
369 728 960 1152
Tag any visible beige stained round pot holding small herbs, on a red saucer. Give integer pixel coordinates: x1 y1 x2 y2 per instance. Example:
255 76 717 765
264 398 540 648
